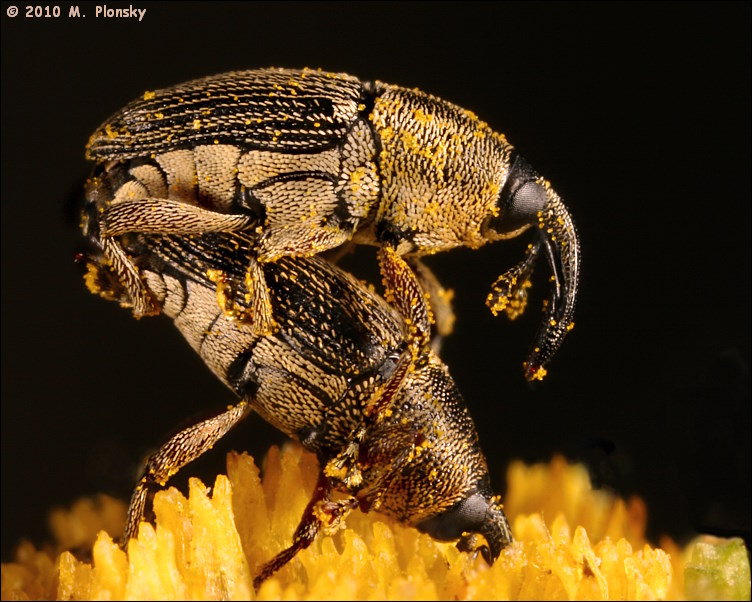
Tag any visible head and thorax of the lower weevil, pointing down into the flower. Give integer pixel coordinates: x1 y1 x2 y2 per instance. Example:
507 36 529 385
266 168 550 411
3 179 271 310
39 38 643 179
361 353 512 564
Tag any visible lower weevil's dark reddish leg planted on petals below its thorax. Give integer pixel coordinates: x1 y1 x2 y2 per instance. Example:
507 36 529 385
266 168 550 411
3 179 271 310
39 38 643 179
253 472 358 589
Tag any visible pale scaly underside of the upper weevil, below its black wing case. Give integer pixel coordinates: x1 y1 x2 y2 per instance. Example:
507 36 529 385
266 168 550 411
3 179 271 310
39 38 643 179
92 130 379 261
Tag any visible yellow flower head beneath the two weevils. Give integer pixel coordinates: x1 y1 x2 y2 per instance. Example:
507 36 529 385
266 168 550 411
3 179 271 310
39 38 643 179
2 446 750 600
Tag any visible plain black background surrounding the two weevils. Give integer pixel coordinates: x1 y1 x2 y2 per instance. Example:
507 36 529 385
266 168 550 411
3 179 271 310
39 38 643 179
0 2 750 560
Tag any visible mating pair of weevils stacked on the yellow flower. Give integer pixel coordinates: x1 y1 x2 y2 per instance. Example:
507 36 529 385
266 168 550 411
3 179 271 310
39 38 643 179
79 69 579 583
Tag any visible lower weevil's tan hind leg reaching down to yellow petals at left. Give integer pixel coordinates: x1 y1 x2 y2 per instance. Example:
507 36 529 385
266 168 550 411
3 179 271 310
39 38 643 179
121 401 252 548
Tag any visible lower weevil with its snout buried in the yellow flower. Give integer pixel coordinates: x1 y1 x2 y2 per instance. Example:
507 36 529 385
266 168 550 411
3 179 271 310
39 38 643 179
84 212 512 587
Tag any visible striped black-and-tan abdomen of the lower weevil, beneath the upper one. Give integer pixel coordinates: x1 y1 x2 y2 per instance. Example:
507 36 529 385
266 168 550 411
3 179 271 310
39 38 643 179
139 235 404 452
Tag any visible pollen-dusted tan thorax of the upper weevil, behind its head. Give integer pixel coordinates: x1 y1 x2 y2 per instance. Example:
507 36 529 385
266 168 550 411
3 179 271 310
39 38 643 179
371 84 513 254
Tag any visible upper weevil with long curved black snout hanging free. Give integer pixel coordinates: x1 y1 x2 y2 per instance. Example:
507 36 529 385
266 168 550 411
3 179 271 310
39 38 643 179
87 69 580 380
